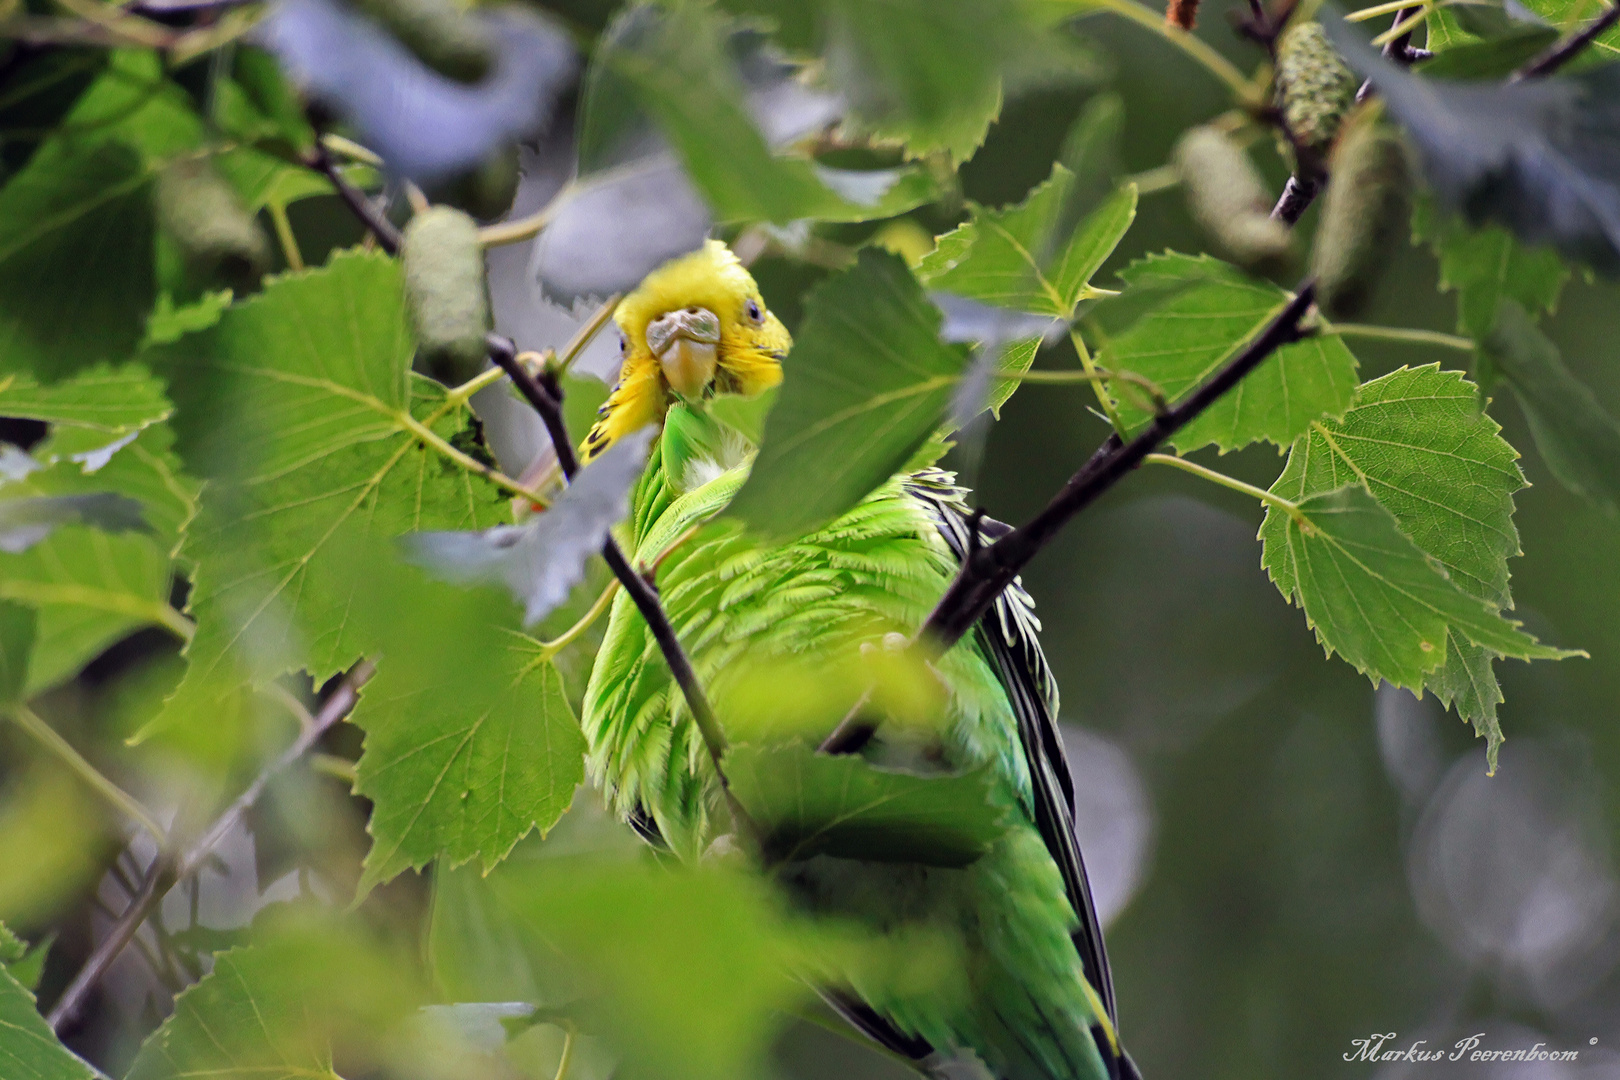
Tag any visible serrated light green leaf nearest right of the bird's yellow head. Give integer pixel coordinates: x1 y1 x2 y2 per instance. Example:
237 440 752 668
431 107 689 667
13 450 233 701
917 165 1136 319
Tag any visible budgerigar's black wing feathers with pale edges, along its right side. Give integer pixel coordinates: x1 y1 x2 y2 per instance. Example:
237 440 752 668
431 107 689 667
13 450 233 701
907 470 1115 1022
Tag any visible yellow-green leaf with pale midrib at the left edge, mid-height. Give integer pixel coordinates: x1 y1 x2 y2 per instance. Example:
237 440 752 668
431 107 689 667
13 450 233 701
0 526 177 696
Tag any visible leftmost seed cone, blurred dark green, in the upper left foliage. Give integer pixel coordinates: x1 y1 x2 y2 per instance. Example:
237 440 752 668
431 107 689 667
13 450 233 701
152 159 271 291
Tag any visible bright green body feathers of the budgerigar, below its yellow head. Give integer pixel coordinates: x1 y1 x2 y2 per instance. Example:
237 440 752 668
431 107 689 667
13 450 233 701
583 453 1113 1080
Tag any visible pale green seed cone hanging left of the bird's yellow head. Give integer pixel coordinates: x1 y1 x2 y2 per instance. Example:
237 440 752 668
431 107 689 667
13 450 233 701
400 206 489 384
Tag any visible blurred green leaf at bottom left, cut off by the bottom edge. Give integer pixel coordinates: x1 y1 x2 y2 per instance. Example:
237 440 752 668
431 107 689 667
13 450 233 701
128 923 420 1080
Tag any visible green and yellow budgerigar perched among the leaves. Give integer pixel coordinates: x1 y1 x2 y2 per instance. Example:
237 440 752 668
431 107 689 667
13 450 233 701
582 241 1136 1080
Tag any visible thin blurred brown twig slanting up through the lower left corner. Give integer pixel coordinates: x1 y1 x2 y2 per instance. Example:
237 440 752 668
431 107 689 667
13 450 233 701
45 661 376 1035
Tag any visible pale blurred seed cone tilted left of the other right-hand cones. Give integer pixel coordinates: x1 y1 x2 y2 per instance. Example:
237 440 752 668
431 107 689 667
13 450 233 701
1173 126 1291 264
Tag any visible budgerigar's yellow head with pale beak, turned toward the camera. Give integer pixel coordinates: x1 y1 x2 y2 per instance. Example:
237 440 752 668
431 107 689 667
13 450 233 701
582 240 792 461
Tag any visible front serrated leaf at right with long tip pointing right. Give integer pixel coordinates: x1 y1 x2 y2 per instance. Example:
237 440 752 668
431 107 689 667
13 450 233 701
1262 484 1571 691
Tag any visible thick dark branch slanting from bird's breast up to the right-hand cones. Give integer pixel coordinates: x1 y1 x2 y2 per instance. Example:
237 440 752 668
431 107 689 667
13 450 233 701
922 280 1315 649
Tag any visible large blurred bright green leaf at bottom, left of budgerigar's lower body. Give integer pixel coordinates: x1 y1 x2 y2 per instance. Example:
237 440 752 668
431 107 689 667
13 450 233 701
492 858 808 1080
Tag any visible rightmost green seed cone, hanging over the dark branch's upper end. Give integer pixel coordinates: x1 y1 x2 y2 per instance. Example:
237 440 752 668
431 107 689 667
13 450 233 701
1311 120 1413 319
